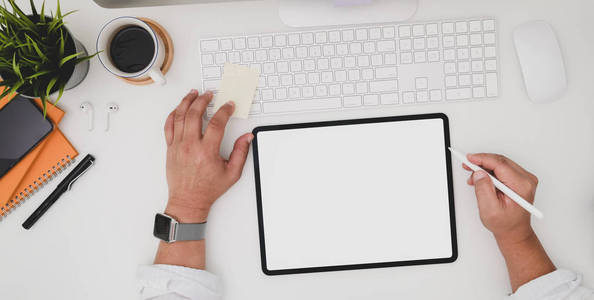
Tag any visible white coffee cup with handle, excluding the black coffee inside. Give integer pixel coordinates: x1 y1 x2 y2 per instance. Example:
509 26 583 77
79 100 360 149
97 17 167 85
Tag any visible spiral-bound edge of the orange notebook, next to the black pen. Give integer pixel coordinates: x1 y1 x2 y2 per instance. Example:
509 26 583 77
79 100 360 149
0 155 76 221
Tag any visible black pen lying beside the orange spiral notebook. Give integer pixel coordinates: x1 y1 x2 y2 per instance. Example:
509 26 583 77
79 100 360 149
23 154 95 229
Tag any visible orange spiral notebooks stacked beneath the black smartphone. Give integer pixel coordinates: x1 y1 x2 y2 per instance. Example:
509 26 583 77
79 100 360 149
0 92 78 219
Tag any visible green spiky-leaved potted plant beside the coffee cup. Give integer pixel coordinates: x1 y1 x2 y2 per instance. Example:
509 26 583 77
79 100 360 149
0 0 96 114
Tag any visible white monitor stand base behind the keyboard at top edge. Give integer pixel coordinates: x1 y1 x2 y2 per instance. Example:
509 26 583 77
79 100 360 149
279 0 418 27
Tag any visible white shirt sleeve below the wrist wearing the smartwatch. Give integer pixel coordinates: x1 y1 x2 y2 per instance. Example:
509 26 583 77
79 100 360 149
137 265 221 300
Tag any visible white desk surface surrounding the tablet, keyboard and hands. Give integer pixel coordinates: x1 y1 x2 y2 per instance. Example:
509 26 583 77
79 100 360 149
0 0 594 299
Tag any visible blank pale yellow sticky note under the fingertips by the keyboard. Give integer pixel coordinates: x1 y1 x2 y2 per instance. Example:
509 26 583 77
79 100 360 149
214 63 260 119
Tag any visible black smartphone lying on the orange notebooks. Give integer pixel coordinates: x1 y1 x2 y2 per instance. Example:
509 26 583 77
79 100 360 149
0 96 54 178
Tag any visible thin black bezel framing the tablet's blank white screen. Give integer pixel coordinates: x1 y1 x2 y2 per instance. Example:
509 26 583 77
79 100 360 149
252 113 458 275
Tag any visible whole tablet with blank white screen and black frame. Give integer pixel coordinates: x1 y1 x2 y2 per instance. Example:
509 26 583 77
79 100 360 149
253 114 457 275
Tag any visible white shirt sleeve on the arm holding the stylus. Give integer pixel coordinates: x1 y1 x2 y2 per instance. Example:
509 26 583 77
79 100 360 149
505 270 594 300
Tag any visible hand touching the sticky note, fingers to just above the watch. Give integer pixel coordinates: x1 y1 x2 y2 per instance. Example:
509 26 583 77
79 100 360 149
165 90 253 223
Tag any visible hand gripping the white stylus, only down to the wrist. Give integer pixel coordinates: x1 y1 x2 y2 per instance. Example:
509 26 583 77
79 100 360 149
464 153 538 243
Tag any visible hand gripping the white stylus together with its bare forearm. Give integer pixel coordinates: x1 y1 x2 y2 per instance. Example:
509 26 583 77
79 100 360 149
464 153 555 292
